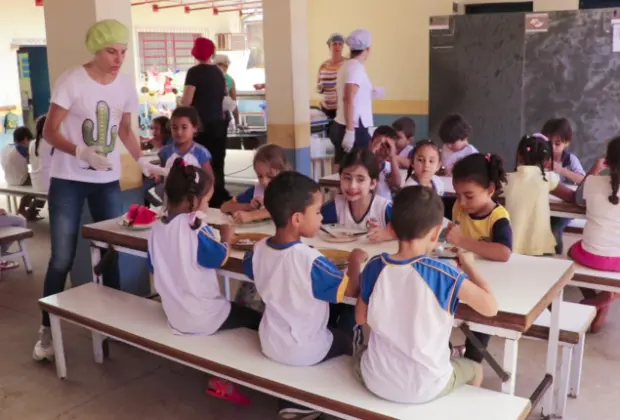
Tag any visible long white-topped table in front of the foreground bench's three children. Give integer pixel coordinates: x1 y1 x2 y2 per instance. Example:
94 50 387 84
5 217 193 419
82 210 573 414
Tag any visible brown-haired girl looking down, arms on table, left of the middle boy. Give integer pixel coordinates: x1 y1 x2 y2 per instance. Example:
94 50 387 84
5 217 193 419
221 144 291 223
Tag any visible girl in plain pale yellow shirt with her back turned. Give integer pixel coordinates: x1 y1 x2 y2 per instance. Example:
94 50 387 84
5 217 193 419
504 134 575 255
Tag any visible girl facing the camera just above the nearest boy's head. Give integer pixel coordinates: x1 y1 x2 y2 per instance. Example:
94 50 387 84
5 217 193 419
405 139 444 196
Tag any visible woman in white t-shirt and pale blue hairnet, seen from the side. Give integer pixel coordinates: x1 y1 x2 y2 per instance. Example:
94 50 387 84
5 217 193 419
329 29 384 171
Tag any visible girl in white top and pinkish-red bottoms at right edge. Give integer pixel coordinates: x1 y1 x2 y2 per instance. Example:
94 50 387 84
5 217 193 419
568 137 620 332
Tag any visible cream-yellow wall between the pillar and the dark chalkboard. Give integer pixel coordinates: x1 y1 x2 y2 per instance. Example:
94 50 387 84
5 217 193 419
308 0 452 114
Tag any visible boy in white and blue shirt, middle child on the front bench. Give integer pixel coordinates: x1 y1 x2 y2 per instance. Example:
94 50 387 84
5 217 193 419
243 172 368 420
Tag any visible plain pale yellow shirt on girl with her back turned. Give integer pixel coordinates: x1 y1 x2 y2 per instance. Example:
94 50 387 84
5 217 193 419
504 165 560 255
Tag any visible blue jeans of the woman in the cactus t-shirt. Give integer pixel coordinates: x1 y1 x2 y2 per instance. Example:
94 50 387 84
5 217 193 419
43 178 123 327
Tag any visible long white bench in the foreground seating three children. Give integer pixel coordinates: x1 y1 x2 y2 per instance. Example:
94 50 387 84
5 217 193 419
39 283 531 420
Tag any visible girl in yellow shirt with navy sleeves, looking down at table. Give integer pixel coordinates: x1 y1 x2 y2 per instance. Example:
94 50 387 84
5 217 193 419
446 153 512 363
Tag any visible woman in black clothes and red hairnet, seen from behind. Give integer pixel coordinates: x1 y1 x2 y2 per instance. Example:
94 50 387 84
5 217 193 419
181 37 231 208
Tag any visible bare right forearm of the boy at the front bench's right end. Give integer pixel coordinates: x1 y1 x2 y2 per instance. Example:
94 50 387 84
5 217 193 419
458 252 497 317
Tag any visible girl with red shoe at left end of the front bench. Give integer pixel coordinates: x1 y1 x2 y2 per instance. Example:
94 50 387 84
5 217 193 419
147 158 261 405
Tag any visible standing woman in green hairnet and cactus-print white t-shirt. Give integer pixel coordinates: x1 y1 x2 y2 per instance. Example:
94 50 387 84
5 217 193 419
33 20 149 360
